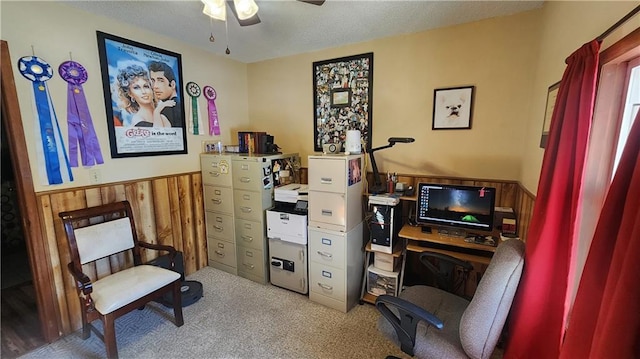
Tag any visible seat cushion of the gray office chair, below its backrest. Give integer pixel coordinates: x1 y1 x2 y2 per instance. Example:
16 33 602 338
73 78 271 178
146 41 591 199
378 285 469 358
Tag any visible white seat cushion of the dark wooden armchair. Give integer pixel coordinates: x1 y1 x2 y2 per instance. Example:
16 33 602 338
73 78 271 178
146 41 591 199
91 265 180 314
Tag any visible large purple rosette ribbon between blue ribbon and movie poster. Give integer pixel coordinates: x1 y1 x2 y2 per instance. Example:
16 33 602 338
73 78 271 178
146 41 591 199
58 61 104 167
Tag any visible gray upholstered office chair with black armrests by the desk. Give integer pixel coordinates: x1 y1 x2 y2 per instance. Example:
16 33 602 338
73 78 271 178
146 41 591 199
376 239 524 359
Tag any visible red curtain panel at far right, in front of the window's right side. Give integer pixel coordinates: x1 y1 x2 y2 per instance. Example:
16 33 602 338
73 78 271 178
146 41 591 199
561 113 640 359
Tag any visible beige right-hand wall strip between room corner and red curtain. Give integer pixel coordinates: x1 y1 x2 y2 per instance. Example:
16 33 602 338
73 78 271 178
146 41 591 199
519 1 640 193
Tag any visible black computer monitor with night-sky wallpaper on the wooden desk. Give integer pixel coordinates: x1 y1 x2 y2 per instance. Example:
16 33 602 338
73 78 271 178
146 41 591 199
416 183 496 231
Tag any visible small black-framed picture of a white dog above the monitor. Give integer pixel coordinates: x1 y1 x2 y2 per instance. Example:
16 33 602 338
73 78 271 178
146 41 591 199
431 86 475 130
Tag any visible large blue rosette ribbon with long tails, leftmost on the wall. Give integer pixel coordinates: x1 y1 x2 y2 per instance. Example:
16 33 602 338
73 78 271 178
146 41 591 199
18 56 73 185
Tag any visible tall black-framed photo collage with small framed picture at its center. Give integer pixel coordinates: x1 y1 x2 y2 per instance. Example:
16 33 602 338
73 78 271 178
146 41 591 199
312 52 373 152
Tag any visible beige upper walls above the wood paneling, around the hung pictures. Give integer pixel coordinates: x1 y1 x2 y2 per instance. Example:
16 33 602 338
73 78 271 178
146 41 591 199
0 1 640 193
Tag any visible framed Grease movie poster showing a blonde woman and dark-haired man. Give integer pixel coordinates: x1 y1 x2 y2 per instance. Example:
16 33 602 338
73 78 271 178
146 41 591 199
97 31 187 158
